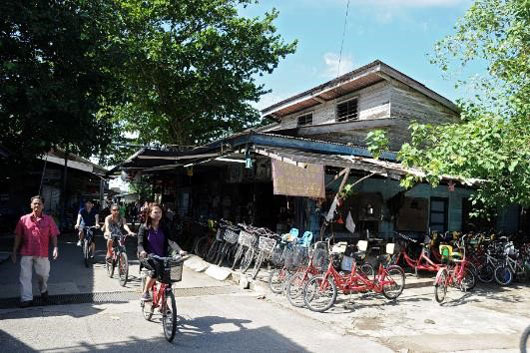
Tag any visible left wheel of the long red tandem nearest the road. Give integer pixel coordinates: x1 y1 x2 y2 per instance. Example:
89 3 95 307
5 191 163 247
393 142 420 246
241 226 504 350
303 276 337 312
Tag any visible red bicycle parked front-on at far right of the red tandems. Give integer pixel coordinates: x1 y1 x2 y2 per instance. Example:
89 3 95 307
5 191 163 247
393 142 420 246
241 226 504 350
434 235 476 304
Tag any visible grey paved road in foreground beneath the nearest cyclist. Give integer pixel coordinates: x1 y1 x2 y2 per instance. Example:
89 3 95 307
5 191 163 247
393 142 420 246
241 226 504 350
0 270 391 353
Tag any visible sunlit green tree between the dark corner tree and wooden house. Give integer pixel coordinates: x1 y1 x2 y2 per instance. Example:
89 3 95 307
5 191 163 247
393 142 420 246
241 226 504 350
114 0 296 145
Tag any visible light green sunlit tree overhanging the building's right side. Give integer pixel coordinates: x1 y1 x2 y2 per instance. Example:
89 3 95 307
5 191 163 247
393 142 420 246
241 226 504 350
399 0 530 213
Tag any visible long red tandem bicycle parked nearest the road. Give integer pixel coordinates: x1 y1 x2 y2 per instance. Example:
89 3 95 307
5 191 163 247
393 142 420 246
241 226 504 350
304 249 405 312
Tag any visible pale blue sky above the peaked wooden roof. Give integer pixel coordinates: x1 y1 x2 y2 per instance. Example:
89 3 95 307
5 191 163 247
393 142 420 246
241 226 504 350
240 0 472 109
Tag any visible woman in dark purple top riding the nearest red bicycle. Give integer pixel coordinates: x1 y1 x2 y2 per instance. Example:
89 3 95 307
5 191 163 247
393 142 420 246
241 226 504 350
138 203 187 301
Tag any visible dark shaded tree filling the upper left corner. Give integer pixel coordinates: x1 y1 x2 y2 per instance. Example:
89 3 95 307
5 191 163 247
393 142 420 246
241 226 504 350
0 0 122 159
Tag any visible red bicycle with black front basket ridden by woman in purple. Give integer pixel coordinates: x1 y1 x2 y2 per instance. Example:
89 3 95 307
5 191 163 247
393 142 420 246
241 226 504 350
140 254 189 342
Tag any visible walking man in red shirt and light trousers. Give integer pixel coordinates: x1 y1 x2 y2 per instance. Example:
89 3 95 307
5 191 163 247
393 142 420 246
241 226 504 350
11 196 59 307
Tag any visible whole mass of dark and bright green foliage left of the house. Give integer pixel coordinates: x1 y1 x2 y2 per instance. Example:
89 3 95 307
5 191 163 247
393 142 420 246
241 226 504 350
0 0 295 161
